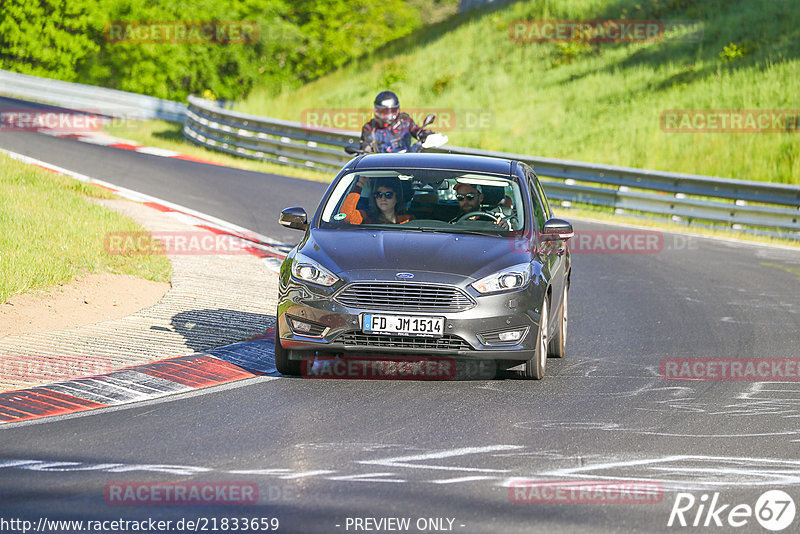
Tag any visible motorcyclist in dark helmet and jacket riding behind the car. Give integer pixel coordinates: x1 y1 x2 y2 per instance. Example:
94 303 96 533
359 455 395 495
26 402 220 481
360 91 433 152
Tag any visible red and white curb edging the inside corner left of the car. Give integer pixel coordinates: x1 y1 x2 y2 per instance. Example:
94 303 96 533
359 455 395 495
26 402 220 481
0 149 290 424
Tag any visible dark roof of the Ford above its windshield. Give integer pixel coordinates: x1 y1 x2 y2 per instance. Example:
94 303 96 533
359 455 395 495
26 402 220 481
354 153 512 176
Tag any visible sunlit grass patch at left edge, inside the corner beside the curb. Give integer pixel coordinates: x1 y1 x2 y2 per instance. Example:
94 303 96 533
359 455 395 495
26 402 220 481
0 155 172 303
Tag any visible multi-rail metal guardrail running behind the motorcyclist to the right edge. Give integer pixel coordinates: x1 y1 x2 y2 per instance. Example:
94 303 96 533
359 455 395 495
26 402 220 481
184 96 800 239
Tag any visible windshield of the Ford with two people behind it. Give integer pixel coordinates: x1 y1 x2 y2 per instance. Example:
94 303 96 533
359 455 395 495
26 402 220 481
320 169 525 235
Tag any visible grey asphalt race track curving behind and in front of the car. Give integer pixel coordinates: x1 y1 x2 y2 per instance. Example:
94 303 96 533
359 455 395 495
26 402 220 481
0 102 800 533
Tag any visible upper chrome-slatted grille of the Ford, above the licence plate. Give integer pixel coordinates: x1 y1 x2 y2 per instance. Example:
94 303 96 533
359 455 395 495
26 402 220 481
335 282 475 312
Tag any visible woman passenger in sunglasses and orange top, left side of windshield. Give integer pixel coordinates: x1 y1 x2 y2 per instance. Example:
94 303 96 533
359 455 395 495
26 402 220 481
341 176 414 224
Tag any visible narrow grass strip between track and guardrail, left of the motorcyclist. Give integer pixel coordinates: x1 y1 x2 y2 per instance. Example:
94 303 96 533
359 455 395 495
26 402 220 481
104 120 336 183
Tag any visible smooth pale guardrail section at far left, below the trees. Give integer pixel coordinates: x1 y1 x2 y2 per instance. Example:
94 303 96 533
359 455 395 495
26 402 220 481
0 70 186 122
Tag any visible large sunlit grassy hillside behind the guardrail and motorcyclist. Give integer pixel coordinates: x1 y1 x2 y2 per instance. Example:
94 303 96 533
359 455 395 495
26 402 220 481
237 0 800 184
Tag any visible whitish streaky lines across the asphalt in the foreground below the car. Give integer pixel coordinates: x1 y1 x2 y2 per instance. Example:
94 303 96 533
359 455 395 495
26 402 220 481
0 445 800 491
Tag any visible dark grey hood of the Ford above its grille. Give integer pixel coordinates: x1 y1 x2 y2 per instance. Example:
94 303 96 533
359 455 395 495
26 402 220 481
300 229 530 279
